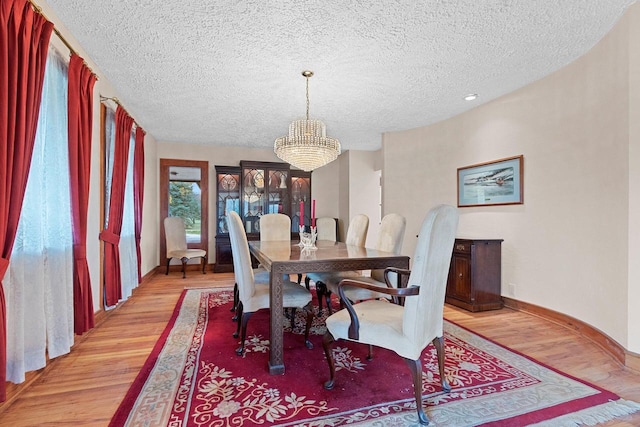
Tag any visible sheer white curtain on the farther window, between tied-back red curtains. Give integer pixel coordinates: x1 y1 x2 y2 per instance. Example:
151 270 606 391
104 108 138 306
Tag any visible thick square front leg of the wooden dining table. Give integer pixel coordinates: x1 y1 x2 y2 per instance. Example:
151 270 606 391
269 268 284 375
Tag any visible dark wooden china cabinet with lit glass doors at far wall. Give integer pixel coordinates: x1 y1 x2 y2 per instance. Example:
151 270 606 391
214 160 311 272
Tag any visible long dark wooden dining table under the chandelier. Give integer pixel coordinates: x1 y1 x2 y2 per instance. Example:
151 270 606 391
249 240 409 375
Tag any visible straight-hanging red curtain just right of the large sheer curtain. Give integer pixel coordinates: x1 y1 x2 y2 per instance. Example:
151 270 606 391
69 53 96 335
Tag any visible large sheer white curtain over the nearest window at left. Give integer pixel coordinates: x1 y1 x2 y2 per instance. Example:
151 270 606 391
3 49 74 383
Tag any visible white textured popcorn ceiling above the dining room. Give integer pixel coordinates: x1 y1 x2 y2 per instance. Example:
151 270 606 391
47 0 634 150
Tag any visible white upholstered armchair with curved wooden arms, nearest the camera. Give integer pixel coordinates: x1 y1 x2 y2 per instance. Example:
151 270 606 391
322 205 458 424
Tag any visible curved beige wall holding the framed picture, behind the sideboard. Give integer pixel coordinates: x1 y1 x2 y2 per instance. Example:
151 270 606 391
383 5 640 352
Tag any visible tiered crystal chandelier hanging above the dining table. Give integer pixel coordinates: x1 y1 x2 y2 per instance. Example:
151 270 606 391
273 71 340 171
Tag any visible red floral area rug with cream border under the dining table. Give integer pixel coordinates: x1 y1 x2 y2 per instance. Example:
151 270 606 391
111 289 640 427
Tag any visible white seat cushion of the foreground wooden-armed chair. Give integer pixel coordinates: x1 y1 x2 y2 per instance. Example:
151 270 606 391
326 300 424 360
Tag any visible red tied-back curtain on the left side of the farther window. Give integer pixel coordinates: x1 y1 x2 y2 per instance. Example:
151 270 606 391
100 106 133 306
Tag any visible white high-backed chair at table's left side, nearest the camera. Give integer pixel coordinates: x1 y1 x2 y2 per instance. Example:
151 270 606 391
227 211 314 355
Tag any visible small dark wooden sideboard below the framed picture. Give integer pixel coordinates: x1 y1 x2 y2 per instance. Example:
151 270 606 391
445 239 502 311
